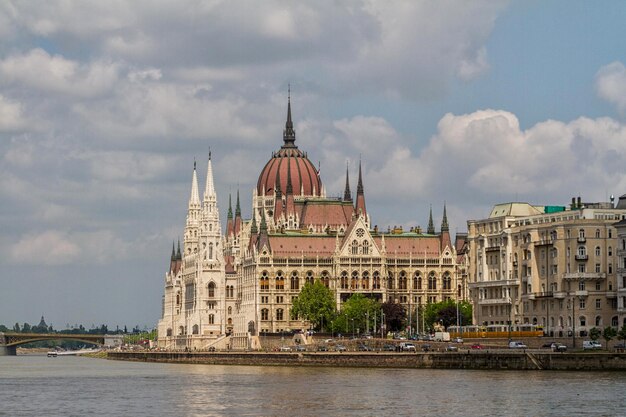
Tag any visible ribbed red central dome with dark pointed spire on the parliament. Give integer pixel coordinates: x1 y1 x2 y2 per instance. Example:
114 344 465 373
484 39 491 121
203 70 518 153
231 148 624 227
257 100 322 196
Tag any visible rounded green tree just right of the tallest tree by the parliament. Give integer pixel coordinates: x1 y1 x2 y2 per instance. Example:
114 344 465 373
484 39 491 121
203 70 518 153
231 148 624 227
333 294 381 333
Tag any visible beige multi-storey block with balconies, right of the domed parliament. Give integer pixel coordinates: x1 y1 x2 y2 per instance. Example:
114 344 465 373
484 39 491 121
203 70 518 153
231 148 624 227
467 198 626 337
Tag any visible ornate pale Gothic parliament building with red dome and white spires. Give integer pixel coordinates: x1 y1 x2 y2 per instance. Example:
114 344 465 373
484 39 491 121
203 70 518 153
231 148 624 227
158 96 467 349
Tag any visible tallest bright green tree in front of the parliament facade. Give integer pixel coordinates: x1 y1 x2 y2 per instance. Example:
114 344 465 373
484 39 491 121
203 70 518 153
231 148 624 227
290 279 336 331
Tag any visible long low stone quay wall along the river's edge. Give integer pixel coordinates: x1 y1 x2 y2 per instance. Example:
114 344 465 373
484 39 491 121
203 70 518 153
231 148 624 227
107 349 626 371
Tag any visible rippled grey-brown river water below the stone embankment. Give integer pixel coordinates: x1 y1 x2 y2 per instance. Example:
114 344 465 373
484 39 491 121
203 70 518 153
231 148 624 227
0 355 626 417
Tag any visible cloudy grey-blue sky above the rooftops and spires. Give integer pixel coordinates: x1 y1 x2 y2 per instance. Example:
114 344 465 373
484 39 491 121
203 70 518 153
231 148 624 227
0 0 626 329
